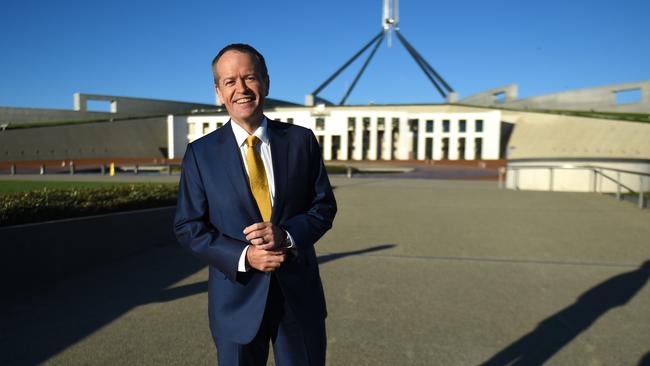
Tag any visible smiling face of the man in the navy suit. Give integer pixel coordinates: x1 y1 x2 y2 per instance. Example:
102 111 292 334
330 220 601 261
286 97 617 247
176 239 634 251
213 50 269 125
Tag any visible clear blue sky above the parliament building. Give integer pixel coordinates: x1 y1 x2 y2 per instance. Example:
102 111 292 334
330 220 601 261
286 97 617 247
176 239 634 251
0 0 650 109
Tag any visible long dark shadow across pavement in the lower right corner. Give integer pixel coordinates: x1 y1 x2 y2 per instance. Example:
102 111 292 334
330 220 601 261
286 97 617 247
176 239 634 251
483 260 650 366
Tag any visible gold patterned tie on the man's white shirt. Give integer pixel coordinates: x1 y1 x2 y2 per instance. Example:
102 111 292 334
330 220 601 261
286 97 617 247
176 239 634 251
246 135 271 221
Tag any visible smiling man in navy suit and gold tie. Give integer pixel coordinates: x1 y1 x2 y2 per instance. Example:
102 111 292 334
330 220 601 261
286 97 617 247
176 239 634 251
175 44 336 366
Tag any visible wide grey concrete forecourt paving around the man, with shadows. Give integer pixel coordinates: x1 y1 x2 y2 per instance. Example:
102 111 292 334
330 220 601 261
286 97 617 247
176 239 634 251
0 178 650 366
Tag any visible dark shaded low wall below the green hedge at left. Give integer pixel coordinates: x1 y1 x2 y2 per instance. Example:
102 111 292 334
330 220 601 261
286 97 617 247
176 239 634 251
0 207 176 292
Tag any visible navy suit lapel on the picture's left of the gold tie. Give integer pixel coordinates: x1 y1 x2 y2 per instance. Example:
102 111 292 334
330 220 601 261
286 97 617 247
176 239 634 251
217 122 262 223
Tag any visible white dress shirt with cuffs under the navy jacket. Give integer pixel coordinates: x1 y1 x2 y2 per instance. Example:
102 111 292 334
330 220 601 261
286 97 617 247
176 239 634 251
230 117 295 272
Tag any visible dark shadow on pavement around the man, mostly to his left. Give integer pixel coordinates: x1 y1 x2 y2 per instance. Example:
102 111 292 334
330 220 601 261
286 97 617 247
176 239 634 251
0 244 395 365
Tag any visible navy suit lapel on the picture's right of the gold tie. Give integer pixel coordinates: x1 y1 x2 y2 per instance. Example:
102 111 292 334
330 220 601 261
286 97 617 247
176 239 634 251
267 118 289 220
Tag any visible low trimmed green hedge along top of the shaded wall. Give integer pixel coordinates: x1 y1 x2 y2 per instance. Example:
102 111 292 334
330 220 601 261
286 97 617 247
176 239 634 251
0 183 178 226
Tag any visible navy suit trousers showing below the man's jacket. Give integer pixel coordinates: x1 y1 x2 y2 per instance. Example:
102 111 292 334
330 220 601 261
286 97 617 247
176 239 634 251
215 274 327 366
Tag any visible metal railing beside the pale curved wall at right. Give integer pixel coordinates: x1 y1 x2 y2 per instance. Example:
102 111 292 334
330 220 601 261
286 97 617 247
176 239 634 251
499 164 650 209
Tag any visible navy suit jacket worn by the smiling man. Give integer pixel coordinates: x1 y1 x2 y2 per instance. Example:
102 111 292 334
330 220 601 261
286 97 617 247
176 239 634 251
174 120 336 343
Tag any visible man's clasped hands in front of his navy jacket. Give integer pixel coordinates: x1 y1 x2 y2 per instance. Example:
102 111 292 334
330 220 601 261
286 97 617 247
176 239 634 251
244 222 287 272
